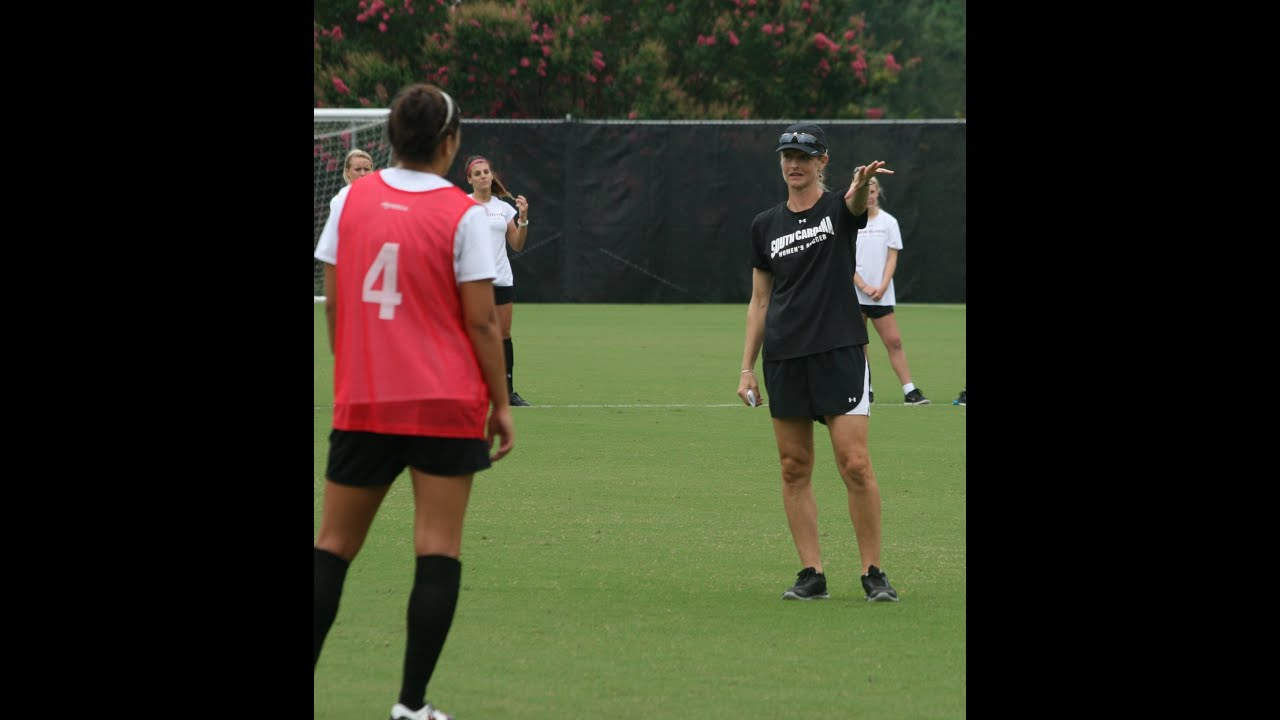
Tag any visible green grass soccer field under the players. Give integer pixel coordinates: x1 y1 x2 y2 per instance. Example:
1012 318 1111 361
312 302 966 720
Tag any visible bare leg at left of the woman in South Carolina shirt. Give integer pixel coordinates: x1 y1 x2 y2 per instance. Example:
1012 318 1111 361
773 418 823 573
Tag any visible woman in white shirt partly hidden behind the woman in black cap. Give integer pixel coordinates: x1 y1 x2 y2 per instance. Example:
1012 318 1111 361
854 177 929 405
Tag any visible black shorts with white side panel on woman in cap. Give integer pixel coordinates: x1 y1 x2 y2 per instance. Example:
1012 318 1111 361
764 345 870 423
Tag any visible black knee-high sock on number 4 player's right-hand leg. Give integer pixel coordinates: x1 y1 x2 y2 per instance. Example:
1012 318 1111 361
399 555 462 710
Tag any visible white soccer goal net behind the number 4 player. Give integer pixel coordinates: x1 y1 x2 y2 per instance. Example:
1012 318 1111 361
311 108 392 302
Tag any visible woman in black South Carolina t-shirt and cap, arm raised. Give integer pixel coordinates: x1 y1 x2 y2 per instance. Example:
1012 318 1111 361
737 123 897 602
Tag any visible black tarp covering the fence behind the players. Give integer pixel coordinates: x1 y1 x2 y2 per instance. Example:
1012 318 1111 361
316 119 965 302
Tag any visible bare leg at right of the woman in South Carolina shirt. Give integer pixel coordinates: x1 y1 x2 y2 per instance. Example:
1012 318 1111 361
827 415 881 574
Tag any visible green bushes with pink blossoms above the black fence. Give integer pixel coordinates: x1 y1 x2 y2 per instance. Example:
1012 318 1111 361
315 0 963 119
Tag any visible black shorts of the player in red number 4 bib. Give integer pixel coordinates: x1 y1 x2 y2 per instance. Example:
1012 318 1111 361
324 430 492 487
